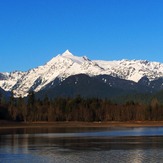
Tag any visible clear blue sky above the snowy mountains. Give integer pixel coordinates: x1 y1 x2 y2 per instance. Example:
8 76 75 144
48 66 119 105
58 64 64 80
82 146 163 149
0 0 163 72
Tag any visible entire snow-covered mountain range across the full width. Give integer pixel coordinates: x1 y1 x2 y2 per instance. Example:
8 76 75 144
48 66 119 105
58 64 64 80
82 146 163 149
0 50 163 97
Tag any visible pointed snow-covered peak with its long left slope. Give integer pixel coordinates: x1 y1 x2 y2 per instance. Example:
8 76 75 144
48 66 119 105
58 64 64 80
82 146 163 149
0 50 101 97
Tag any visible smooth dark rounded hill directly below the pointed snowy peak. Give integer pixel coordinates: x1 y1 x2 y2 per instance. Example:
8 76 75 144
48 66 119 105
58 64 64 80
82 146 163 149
36 74 122 98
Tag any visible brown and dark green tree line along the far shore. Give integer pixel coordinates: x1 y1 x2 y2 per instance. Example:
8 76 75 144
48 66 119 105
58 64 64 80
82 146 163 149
0 92 163 122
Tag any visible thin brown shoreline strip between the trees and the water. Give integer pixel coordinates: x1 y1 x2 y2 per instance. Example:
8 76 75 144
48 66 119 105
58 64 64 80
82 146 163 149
0 121 163 130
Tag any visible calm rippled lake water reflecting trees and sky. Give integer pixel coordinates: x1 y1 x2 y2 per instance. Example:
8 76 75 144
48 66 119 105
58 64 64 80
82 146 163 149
0 127 163 163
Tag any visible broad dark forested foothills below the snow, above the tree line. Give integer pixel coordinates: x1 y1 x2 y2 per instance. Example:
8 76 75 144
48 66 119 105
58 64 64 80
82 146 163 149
36 74 153 99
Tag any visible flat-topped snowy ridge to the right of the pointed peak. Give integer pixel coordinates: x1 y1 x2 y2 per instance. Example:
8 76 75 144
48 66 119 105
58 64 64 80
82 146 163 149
94 60 163 82
